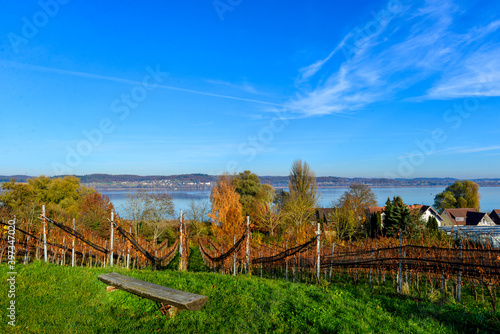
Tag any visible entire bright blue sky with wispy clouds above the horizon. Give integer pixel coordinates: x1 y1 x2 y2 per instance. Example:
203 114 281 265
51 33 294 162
0 0 500 178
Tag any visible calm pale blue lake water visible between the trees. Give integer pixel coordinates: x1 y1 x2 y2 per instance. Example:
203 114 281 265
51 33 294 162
101 187 500 217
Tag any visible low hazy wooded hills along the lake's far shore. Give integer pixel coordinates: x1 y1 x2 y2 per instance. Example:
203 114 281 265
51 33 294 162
0 173 500 189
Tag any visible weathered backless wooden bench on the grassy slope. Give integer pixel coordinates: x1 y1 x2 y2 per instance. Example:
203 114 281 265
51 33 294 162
98 273 208 316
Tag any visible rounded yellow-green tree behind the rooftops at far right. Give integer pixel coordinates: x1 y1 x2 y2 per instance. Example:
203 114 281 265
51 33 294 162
434 180 481 211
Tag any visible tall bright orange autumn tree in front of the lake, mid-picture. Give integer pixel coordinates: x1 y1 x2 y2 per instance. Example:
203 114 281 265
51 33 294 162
208 173 245 240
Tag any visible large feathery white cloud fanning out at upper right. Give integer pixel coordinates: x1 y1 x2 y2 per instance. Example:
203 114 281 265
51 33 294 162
287 0 500 117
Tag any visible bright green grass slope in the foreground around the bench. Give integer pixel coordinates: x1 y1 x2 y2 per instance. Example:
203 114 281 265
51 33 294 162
0 262 500 334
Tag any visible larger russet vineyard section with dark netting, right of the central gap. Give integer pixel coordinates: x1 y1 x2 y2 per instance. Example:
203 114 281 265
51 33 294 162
199 224 500 309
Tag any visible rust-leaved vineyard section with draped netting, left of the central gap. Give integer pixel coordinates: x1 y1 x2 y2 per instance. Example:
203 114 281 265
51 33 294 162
0 217 179 269
